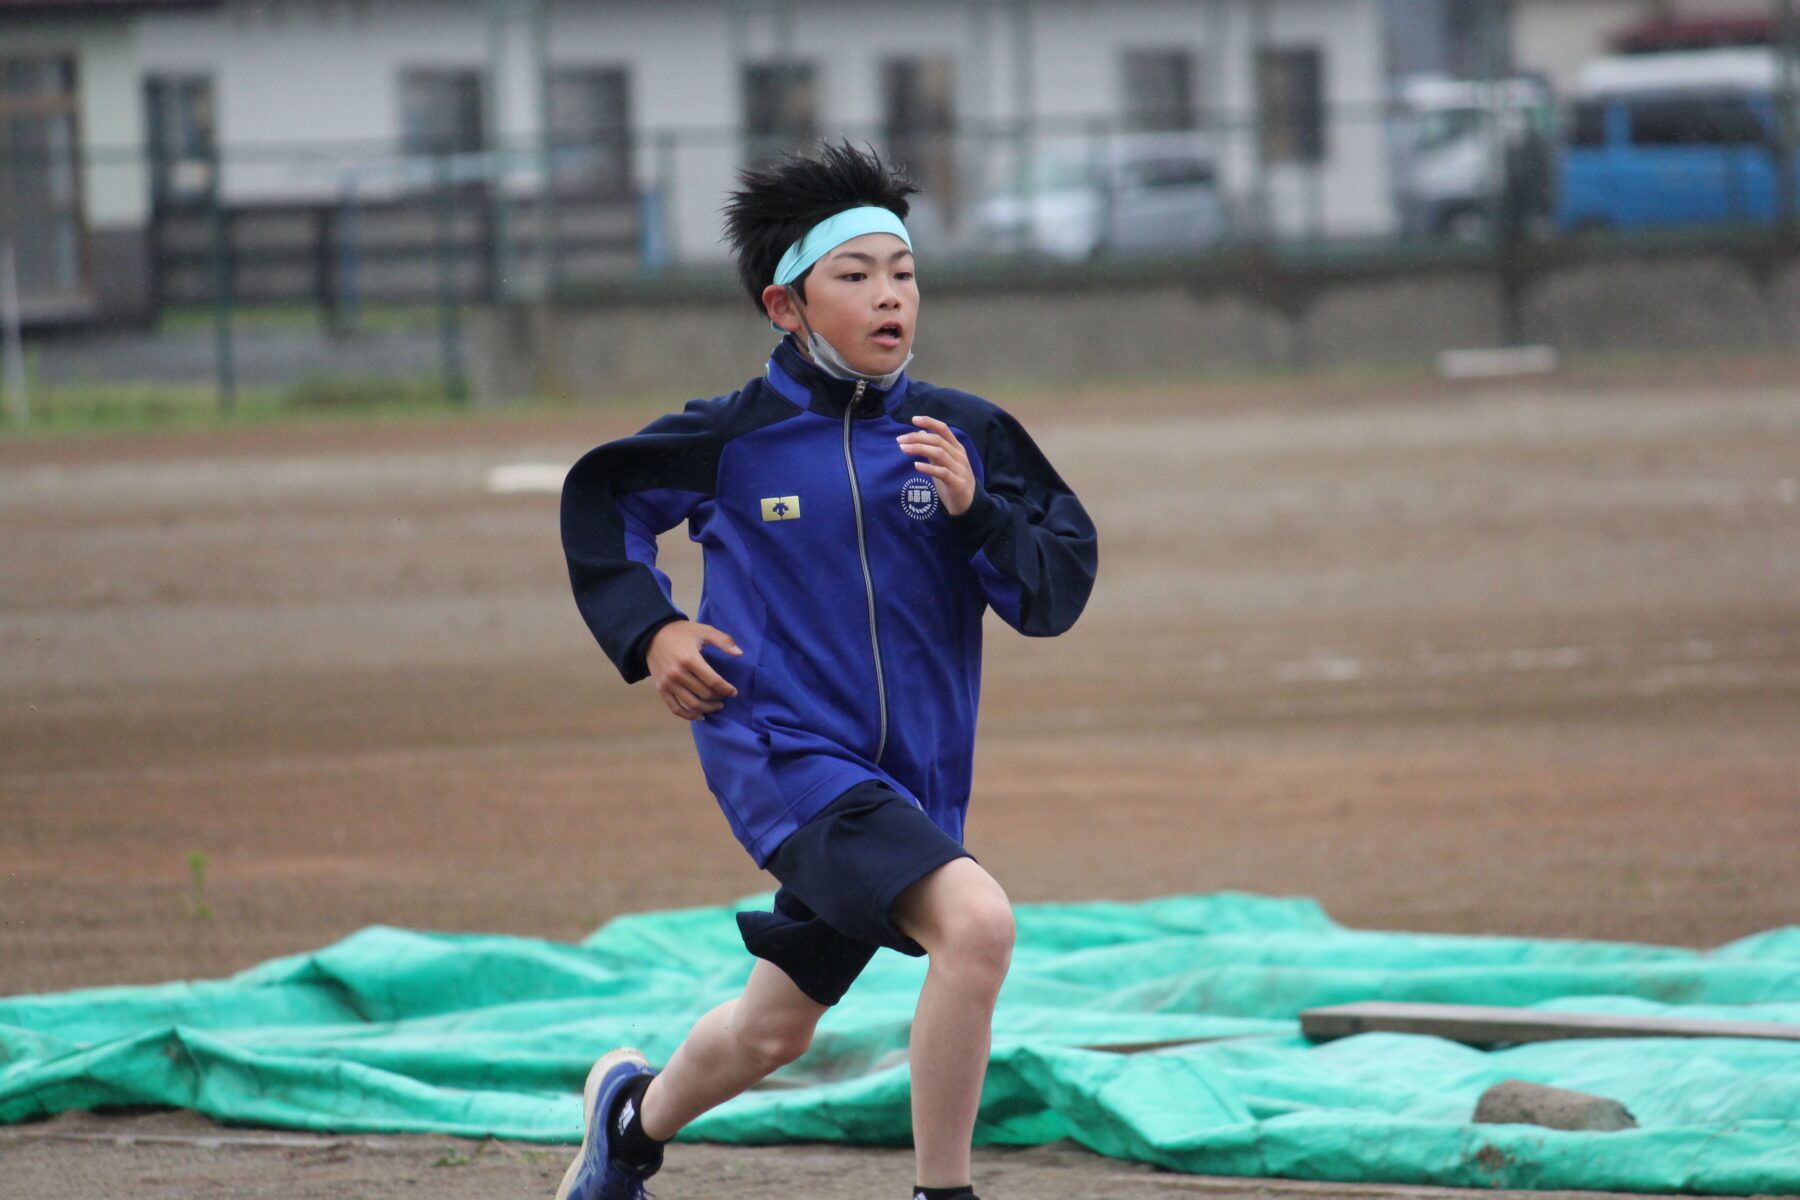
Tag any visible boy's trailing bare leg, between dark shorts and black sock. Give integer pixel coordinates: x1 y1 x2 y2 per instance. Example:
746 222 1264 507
643 959 828 1141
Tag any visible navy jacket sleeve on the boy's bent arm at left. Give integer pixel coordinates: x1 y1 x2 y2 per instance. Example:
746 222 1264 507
562 401 724 684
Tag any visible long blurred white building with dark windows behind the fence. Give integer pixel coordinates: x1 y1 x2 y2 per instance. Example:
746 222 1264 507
0 0 1393 323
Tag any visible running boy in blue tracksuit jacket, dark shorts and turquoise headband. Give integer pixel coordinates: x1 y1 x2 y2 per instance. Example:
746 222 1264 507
556 144 1096 1200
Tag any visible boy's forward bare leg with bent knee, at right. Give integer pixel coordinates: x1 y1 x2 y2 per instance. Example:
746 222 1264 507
895 858 1013 1187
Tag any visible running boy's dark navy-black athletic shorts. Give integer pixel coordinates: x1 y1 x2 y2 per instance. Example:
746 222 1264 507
738 779 972 1004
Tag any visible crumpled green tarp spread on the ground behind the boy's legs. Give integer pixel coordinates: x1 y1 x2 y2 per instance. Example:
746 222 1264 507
0 894 1800 1195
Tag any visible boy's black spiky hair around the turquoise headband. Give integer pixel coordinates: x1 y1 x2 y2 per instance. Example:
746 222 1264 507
724 140 918 311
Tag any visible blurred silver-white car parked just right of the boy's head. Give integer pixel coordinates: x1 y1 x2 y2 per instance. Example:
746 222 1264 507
974 135 1226 261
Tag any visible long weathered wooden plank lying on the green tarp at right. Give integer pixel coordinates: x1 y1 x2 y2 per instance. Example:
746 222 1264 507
1300 1000 1800 1047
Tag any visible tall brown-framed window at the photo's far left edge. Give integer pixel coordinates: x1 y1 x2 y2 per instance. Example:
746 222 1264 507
0 56 86 299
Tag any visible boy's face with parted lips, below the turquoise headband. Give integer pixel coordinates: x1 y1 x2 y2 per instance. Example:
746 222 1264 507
763 234 918 374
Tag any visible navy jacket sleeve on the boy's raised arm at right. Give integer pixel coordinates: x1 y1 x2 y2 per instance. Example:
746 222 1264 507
950 408 1100 637
